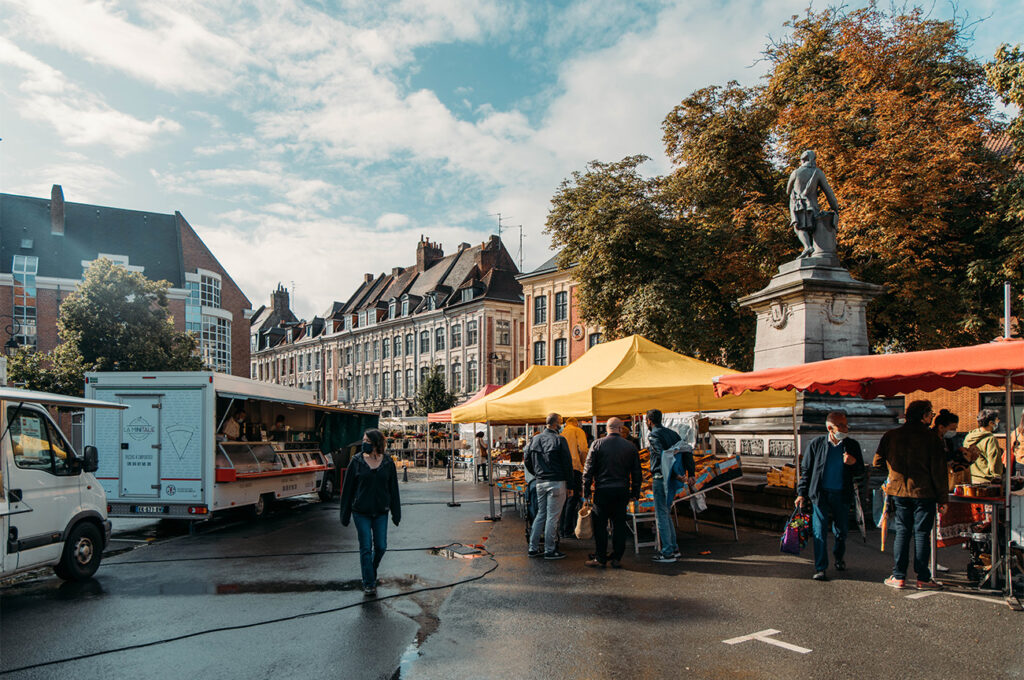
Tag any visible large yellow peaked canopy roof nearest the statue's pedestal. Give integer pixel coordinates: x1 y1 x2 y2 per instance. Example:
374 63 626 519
486 335 797 423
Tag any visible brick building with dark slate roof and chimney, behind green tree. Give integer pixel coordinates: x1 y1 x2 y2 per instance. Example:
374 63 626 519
0 184 251 376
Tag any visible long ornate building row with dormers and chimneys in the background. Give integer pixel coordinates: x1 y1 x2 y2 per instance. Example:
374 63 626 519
252 236 526 417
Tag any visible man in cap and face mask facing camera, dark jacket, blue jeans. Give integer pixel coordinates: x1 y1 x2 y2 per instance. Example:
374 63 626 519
797 411 864 581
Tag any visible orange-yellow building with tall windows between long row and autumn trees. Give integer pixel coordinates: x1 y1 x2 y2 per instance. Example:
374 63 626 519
518 255 602 366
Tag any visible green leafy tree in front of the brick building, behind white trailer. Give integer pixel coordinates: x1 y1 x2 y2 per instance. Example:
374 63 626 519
9 258 203 395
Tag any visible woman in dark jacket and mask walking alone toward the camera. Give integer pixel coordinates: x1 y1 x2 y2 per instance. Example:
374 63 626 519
341 430 401 597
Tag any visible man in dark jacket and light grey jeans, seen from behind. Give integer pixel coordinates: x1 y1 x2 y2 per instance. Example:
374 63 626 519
523 413 572 559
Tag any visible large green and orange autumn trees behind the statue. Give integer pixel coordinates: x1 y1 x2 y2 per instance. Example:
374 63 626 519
547 5 1024 368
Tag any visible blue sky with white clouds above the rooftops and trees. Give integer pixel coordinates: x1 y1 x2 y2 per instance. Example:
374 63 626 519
0 0 1024 317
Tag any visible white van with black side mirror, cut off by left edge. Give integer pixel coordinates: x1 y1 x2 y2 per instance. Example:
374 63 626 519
0 387 124 581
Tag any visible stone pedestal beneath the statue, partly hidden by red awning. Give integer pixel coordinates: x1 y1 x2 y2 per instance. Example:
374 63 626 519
713 258 898 470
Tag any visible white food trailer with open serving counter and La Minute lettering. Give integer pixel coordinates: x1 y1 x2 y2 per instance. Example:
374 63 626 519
83 372 377 521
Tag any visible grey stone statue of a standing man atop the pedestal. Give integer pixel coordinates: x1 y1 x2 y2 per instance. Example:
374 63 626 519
785 151 839 259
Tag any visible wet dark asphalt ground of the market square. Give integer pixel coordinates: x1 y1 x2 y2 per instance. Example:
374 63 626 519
0 482 1024 679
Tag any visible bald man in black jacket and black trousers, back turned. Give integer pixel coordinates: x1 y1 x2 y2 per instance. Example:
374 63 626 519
583 418 642 568
